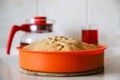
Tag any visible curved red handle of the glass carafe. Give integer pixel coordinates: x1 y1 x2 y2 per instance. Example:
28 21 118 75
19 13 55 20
6 24 30 55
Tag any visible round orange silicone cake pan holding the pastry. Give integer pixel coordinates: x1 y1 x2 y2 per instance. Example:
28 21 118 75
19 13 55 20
17 45 106 73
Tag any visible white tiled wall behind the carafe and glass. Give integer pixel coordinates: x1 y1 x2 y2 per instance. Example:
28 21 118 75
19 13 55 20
0 0 120 48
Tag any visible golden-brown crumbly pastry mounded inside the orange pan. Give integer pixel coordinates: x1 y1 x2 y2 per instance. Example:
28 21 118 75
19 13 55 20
23 36 98 51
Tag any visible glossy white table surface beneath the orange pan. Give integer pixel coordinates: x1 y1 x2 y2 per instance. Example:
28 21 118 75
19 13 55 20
0 48 120 80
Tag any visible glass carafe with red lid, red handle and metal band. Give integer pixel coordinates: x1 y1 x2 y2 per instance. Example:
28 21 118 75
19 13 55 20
7 16 56 54
